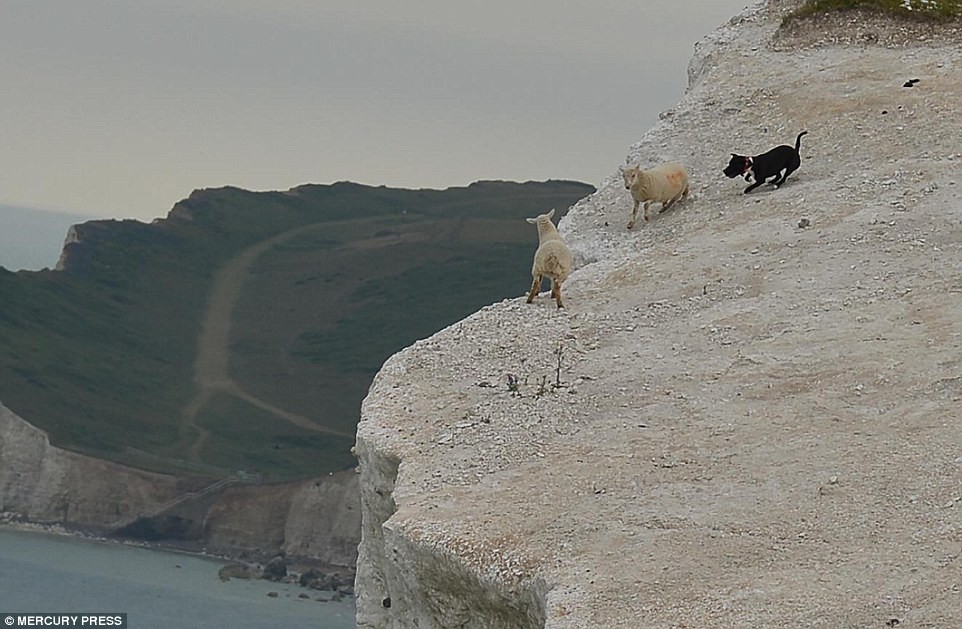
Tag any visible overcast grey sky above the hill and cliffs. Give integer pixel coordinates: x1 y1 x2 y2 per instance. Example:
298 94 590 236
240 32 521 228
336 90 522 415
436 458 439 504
0 0 750 220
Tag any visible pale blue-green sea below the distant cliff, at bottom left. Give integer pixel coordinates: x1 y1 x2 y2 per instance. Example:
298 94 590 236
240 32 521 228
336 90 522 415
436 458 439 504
0 526 357 629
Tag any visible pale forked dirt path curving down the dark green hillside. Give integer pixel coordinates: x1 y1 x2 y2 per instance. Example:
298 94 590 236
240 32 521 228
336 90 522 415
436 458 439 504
181 225 353 461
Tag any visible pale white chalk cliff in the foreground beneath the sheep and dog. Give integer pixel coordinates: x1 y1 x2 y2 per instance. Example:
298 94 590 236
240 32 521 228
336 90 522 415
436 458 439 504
356 1 962 629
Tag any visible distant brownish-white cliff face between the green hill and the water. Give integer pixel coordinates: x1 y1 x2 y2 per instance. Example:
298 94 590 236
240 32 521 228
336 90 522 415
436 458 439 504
0 405 360 570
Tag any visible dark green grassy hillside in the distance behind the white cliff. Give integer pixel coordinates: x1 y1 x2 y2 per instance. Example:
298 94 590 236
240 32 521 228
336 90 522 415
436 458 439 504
0 181 594 480
